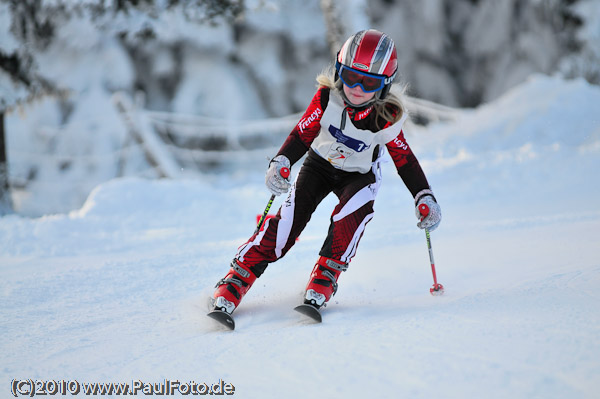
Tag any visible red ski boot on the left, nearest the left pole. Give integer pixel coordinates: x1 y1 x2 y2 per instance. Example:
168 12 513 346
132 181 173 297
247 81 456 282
212 259 256 314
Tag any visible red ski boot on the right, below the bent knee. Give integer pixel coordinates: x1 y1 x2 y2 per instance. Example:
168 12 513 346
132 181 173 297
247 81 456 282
304 256 348 309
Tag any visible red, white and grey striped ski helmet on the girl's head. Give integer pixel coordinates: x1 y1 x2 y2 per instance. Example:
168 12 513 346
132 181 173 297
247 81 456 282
335 29 398 99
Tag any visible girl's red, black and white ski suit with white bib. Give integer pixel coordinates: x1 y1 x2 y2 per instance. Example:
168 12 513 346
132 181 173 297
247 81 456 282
237 87 429 277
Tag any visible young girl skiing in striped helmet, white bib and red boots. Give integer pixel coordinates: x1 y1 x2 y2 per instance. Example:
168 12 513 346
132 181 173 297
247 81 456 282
212 29 441 323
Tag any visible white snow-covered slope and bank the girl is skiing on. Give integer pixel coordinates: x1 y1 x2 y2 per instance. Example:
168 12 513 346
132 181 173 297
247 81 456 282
0 76 600 398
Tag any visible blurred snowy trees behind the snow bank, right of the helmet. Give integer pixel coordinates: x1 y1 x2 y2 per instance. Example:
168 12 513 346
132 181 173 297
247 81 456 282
369 0 600 106
